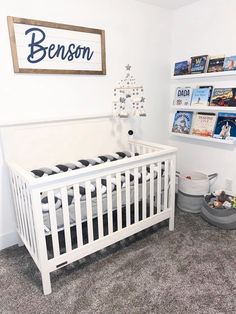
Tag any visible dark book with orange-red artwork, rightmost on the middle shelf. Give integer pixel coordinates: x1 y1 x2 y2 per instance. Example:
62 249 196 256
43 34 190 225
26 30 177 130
210 88 236 107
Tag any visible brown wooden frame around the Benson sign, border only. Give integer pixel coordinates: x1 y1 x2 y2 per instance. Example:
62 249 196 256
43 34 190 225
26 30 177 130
7 16 106 75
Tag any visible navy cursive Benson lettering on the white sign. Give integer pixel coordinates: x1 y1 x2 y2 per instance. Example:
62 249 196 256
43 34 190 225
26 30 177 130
25 27 94 63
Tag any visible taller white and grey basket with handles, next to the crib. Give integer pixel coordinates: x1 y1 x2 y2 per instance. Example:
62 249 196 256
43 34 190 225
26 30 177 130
176 171 218 214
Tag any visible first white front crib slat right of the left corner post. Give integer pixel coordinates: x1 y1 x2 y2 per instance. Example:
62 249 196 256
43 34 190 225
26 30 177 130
48 191 60 257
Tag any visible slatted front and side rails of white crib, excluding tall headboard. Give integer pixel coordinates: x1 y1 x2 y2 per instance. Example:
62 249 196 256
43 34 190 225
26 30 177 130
7 141 176 294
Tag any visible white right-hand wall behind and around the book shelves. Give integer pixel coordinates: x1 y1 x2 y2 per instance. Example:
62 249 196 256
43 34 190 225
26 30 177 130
170 0 236 194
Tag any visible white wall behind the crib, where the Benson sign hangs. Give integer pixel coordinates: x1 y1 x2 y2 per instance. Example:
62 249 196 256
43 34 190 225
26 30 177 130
0 0 171 249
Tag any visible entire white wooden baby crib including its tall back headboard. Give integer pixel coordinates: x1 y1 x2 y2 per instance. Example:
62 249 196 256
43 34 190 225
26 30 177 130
2 118 176 294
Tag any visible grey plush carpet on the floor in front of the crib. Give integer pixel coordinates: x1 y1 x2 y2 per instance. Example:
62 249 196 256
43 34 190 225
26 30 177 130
0 211 236 314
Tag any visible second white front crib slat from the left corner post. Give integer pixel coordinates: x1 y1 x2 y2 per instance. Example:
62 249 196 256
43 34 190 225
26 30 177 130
61 187 72 252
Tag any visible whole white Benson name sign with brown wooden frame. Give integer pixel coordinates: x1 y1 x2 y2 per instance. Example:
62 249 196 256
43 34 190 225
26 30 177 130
7 16 106 75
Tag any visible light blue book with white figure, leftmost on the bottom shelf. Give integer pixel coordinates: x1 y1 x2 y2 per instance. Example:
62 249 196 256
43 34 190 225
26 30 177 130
172 111 193 134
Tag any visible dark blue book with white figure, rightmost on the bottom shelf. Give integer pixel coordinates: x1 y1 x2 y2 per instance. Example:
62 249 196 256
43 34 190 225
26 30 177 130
213 112 236 140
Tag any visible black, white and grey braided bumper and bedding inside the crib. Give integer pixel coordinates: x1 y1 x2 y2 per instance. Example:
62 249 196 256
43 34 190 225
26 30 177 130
31 151 164 234
